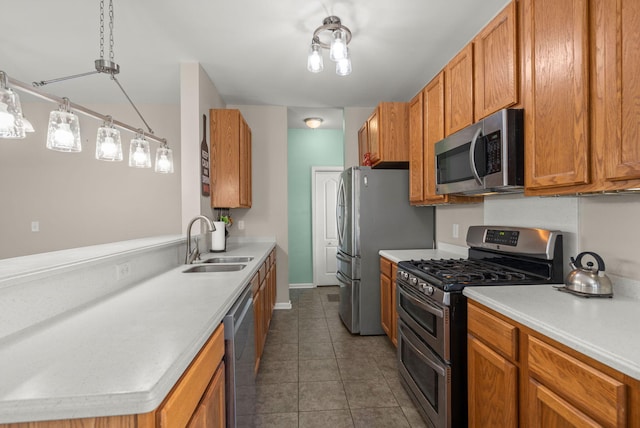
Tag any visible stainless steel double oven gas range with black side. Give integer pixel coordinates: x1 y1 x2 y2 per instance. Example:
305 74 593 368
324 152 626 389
397 226 563 428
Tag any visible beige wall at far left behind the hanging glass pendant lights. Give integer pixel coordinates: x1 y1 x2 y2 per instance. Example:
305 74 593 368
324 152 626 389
0 100 181 258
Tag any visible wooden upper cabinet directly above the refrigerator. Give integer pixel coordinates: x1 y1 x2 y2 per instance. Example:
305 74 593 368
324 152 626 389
367 102 409 166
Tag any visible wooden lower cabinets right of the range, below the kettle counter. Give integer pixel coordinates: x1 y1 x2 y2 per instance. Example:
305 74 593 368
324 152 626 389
468 301 640 428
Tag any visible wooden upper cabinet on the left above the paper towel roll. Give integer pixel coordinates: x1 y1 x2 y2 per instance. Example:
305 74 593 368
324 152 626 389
209 109 251 208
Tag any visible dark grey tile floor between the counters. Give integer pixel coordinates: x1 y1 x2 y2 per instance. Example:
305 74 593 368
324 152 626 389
248 287 425 428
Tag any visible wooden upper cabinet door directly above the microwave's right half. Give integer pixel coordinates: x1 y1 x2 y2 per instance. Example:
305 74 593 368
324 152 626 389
473 1 519 120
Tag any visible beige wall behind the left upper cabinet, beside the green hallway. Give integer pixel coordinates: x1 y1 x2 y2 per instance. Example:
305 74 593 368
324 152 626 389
228 105 289 305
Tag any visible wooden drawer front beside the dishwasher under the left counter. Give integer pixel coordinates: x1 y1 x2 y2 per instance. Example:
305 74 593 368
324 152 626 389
157 324 224 427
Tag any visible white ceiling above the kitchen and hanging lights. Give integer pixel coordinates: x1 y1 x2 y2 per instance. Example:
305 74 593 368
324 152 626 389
0 0 508 129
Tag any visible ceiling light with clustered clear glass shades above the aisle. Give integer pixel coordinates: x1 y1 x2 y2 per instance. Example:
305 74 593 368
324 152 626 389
307 16 351 76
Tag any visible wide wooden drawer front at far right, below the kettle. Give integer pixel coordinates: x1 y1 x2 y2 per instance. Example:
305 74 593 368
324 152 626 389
528 336 626 427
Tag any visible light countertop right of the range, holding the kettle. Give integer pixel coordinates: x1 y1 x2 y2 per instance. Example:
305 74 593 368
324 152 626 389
463 285 640 380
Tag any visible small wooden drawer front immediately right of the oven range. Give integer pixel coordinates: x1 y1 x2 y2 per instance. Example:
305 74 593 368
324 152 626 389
467 305 518 361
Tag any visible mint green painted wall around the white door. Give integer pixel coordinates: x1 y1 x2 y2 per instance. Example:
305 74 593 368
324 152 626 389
287 129 344 284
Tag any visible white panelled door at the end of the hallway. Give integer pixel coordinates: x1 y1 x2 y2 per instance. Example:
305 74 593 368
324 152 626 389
311 167 342 286
